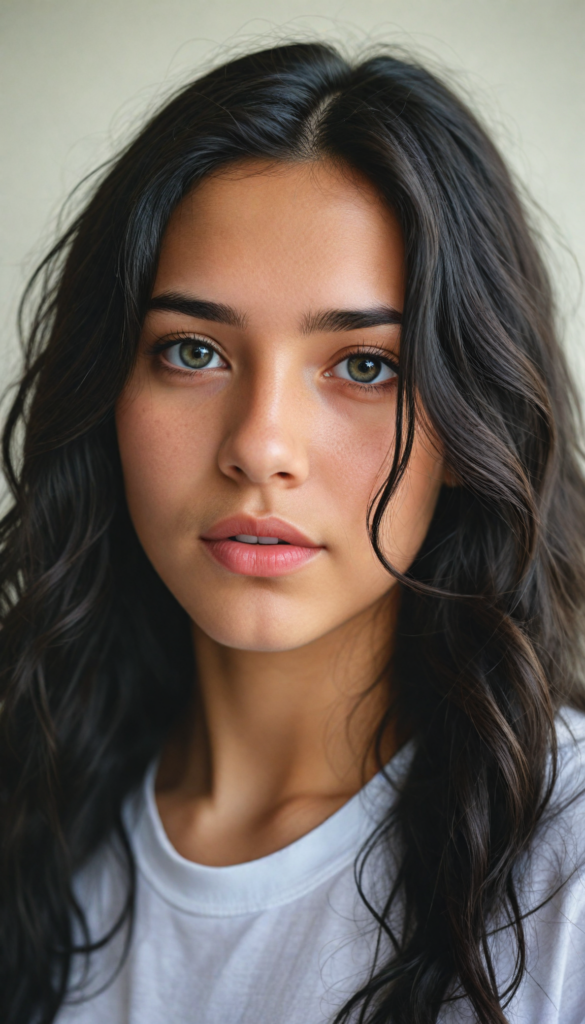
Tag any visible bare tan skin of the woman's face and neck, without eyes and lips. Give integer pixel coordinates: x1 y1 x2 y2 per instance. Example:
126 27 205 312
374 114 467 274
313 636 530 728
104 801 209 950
117 163 444 864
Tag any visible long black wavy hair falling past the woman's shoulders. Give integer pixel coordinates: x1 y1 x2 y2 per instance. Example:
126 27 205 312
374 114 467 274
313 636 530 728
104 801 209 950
0 43 585 1024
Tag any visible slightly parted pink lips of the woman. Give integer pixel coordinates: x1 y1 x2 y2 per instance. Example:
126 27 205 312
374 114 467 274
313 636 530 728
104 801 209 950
201 515 323 577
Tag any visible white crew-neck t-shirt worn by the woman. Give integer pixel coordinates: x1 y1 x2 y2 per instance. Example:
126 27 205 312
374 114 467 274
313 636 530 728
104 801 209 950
57 712 585 1024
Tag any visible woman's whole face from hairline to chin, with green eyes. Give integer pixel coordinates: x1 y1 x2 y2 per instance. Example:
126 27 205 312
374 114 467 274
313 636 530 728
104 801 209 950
117 163 443 650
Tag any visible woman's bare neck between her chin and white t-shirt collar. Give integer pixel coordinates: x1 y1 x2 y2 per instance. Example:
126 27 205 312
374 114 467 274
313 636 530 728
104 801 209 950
156 589 398 866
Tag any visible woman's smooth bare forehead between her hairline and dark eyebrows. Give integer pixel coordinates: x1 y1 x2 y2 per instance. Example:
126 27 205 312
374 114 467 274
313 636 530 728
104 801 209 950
155 162 404 314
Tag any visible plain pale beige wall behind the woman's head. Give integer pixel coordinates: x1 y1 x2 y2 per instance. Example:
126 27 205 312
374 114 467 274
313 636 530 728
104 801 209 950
0 0 585 392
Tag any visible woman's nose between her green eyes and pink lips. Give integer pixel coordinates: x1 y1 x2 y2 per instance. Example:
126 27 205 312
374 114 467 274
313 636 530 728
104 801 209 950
218 368 308 487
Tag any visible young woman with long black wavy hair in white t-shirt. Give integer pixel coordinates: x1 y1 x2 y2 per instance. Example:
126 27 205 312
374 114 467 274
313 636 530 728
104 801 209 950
0 44 585 1024
